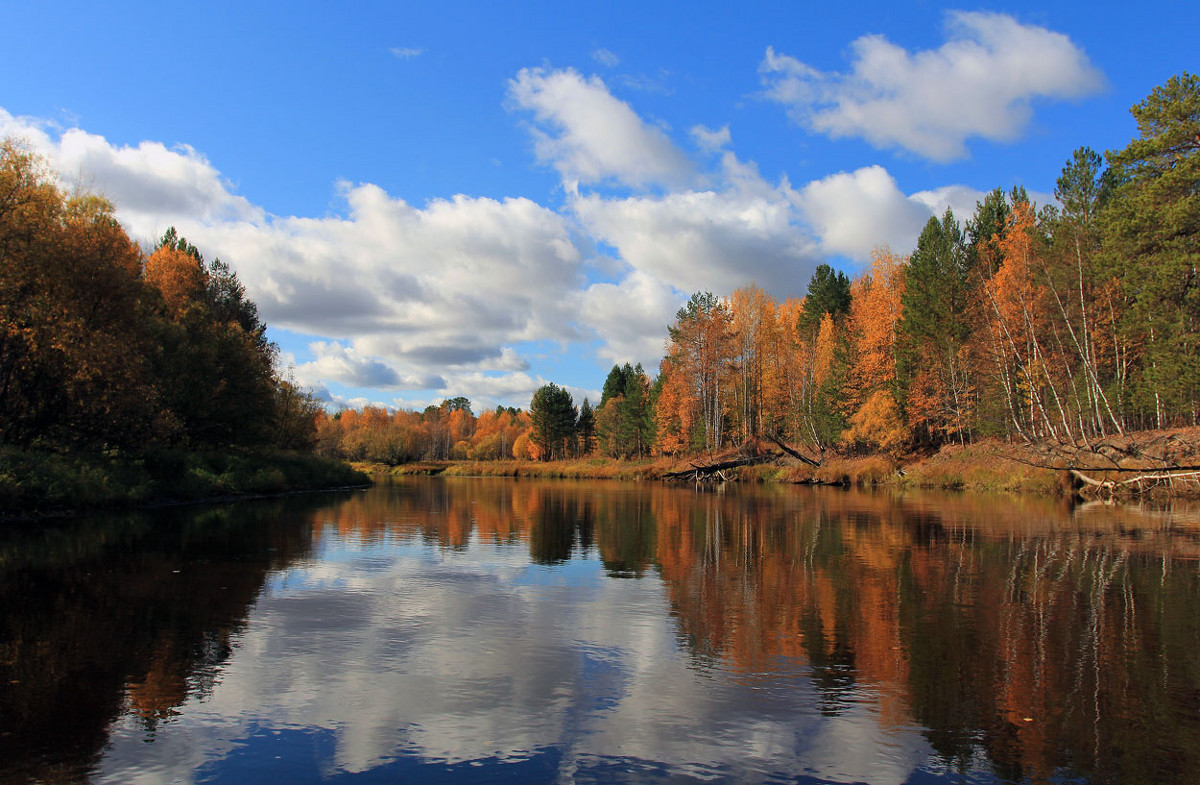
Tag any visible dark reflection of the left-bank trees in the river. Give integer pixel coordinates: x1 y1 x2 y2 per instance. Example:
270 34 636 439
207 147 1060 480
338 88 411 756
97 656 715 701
0 502 326 781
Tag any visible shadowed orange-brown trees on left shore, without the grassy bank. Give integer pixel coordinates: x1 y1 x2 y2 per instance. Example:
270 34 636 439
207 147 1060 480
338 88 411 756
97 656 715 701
0 139 319 450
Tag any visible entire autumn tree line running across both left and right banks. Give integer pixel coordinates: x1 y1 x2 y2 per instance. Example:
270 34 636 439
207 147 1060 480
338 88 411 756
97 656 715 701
0 73 1200 492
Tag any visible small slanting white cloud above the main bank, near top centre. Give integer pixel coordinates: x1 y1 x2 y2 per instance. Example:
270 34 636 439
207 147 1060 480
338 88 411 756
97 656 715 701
509 68 691 186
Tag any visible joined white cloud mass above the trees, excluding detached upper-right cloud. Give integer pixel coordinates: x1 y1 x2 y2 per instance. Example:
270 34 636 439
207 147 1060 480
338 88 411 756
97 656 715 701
0 79 1022 406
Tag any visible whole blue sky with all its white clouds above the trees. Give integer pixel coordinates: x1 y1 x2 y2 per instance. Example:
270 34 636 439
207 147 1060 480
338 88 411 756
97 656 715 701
0 2 1200 412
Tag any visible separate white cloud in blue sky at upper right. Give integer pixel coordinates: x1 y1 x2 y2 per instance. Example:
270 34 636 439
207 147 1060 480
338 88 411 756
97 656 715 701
760 12 1103 162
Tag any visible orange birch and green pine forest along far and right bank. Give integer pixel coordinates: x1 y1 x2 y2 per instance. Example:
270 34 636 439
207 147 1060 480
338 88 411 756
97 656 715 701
318 73 1200 463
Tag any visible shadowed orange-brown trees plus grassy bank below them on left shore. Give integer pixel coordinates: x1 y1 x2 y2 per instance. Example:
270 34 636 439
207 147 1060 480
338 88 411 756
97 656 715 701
0 145 367 521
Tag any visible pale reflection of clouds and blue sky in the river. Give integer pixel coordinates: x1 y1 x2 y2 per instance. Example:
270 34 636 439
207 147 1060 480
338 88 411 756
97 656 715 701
97 511 929 784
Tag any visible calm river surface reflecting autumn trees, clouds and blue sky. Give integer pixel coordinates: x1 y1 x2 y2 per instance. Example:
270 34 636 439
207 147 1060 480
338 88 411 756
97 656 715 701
0 479 1200 784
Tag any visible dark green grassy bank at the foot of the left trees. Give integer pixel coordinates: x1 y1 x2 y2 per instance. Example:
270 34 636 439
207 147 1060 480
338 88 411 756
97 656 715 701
0 447 370 517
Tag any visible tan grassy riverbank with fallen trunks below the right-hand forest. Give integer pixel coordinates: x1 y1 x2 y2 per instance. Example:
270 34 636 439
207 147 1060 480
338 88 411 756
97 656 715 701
355 429 1200 497
